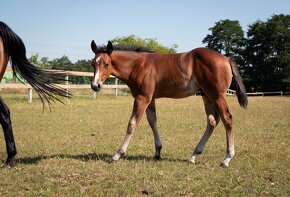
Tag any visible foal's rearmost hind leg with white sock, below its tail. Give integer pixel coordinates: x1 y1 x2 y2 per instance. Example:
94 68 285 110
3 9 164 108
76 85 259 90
215 96 235 167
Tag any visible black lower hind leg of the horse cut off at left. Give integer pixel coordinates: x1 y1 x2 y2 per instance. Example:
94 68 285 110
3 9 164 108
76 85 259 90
0 97 17 167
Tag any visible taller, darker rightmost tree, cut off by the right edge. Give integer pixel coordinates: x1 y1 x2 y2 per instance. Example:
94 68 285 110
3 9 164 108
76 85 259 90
245 14 290 91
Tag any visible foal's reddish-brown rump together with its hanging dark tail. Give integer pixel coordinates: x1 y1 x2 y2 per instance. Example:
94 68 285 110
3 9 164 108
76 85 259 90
190 48 248 108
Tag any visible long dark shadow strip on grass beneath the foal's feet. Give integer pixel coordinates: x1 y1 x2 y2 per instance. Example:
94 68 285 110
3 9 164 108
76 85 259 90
16 153 187 165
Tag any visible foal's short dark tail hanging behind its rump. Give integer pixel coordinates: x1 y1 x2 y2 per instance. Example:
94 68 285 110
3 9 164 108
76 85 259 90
229 57 248 109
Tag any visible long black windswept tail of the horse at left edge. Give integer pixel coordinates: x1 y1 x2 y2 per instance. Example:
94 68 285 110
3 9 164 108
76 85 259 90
0 21 71 108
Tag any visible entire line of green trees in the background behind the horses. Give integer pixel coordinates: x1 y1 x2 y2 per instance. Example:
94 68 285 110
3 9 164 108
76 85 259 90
30 14 290 92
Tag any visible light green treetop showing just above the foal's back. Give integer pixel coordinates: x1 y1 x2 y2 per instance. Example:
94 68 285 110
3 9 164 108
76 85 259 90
111 35 178 54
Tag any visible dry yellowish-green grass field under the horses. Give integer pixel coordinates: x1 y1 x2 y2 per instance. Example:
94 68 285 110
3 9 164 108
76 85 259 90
0 94 290 196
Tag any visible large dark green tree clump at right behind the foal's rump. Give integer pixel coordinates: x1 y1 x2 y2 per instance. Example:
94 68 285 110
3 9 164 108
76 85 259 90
203 14 290 91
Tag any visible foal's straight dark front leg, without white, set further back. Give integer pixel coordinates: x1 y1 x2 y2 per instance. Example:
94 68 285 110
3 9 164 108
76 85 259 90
146 100 162 159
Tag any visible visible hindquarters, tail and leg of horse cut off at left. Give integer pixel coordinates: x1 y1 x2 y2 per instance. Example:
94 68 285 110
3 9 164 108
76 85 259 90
0 21 70 167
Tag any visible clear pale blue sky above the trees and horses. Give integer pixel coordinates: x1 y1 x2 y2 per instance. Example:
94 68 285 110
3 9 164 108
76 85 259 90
0 0 290 62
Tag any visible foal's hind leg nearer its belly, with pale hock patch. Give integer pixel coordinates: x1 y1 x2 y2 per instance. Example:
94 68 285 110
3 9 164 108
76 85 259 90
188 96 220 163
